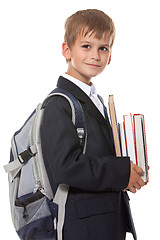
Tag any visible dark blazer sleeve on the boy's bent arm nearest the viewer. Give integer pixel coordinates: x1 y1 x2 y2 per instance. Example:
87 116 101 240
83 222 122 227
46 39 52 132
41 96 130 191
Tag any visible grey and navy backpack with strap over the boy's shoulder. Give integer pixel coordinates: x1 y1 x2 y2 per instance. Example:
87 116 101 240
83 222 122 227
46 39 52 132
4 88 87 240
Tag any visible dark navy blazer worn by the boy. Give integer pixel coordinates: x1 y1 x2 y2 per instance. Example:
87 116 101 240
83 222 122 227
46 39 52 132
41 77 137 240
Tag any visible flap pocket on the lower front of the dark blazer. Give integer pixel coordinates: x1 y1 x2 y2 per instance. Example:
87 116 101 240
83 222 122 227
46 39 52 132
76 195 114 218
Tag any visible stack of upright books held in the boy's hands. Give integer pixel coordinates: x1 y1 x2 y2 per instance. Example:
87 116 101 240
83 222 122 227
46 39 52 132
109 95 149 182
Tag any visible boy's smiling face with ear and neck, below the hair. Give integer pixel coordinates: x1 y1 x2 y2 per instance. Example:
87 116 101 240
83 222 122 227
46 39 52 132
62 33 111 84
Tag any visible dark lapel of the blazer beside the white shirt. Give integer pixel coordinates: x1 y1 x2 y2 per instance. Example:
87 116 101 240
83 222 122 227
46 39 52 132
57 77 114 154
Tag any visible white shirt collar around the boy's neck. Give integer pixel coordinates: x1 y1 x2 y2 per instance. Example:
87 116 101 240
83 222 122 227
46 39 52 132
62 73 97 97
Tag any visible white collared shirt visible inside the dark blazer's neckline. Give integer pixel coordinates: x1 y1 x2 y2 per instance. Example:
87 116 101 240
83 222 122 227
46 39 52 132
62 73 105 117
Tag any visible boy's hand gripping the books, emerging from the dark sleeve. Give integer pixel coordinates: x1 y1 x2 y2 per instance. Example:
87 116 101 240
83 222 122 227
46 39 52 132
124 163 145 193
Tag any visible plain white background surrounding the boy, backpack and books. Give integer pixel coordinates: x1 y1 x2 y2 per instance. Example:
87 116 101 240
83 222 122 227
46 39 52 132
0 0 160 240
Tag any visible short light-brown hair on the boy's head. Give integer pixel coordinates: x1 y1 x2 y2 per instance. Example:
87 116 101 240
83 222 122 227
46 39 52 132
64 9 115 48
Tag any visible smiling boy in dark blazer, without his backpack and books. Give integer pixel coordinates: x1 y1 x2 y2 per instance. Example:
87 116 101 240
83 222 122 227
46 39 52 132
41 9 144 240
